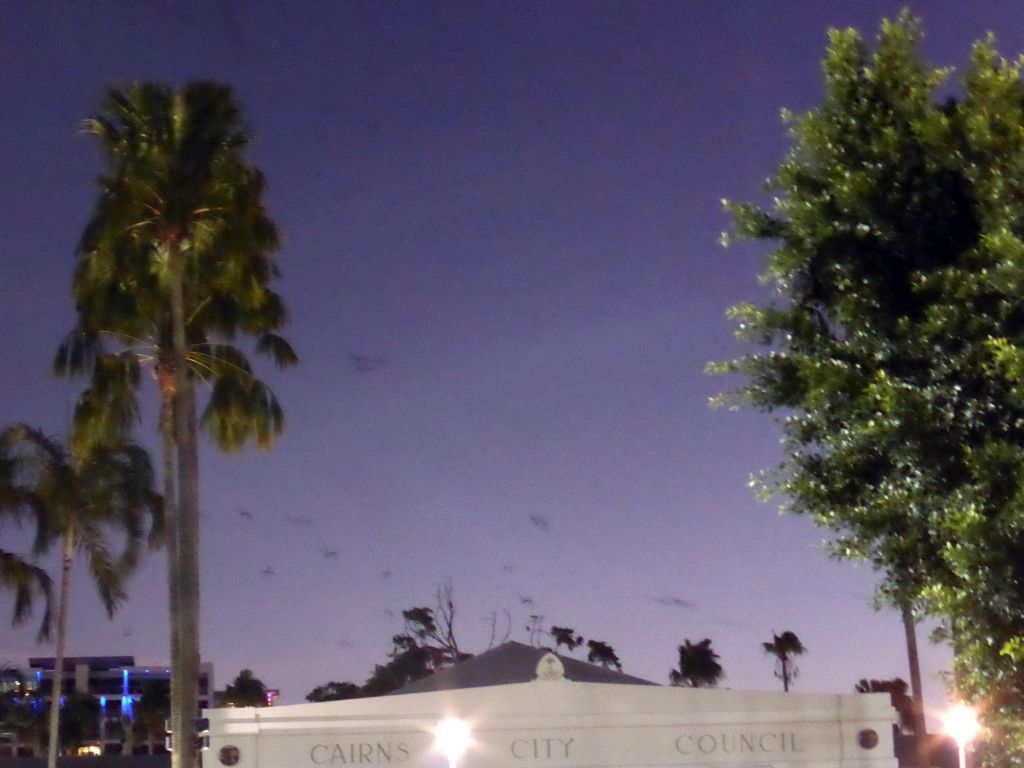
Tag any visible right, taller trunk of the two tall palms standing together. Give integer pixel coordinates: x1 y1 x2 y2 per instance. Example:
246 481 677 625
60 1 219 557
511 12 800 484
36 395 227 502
168 237 200 768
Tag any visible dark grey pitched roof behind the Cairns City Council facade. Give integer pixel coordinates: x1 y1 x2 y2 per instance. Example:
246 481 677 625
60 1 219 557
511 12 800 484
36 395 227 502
388 642 657 695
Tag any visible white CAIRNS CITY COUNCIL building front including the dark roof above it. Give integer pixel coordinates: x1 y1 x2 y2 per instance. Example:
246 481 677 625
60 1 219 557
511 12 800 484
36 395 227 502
204 644 897 768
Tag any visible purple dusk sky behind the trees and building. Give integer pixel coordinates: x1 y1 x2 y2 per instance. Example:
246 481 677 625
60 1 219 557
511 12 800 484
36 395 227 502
0 0 1024 720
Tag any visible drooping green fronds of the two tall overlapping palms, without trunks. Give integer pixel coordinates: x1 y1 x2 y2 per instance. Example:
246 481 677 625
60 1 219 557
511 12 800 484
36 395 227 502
54 82 297 451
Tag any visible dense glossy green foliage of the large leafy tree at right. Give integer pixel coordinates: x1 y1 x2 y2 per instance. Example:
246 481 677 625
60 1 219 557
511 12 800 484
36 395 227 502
711 12 1024 765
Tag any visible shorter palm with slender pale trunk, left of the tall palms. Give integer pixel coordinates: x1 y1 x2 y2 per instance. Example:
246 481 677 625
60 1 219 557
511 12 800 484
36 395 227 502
0 424 161 768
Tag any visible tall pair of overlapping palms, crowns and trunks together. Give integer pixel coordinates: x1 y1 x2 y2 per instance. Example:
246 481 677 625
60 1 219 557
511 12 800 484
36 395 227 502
58 82 296 768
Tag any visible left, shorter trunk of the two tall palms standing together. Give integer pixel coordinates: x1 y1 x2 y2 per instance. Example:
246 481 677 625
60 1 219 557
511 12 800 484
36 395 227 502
158 387 185 761
